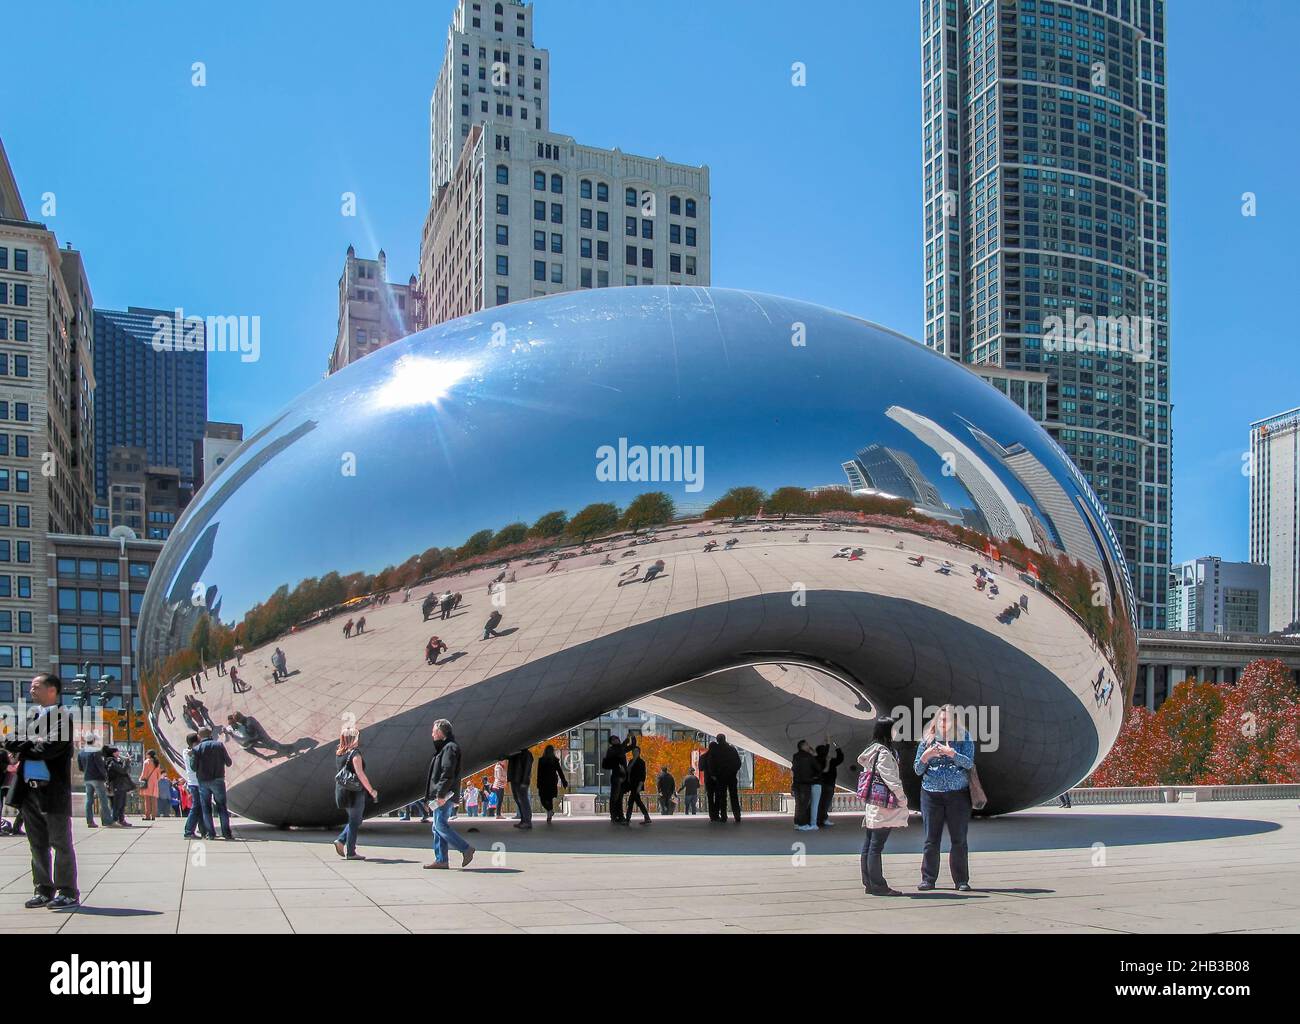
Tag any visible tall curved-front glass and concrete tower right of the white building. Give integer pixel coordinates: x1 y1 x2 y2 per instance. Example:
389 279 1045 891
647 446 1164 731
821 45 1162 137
920 0 1171 628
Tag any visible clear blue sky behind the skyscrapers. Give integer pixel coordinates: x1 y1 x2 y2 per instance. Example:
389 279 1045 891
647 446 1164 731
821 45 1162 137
0 0 1300 559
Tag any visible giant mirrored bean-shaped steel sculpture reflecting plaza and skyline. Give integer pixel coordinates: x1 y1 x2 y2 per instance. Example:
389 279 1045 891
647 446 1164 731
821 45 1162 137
139 287 1136 825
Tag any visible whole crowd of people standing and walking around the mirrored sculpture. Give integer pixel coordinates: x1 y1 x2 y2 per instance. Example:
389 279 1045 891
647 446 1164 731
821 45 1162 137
4 673 983 908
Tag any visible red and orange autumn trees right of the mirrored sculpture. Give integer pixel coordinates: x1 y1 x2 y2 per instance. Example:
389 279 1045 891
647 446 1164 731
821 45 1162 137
1082 660 1300 786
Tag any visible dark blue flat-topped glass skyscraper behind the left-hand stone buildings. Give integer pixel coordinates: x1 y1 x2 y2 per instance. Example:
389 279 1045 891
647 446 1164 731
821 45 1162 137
95 305 208 506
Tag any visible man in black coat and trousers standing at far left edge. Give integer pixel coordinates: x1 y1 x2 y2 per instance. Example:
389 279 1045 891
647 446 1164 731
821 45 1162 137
4 672 81 910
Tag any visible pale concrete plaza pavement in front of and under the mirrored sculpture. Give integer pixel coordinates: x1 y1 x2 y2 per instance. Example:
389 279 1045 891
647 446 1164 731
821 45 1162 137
0 800 1300 934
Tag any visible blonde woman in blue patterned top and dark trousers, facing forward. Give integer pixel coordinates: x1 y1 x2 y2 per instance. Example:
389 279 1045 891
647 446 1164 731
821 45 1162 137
911 704 975 893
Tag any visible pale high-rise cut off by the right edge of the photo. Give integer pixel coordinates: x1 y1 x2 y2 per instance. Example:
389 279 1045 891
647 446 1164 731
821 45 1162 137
1251 408 1300 632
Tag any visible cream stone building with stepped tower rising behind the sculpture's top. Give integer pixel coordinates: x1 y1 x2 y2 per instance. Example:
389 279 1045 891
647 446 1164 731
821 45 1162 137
417 0 710 324
